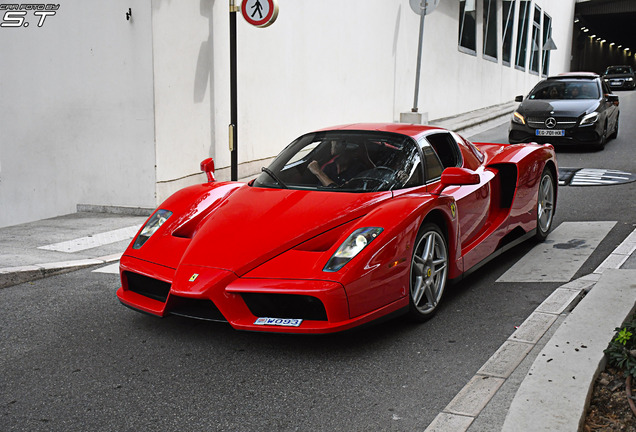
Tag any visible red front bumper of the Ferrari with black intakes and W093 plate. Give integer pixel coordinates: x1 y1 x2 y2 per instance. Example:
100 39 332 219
117 257 408 334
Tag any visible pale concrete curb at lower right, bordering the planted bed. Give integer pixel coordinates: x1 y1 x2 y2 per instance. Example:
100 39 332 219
425 230 636 432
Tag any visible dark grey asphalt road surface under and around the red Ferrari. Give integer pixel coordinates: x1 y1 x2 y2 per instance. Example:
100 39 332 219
0 89 636 431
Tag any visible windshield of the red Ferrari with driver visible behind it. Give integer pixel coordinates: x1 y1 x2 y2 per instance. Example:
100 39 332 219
254 131 422 192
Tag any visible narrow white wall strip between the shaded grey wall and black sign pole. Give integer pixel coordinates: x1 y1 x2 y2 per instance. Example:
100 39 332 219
152 0 219 202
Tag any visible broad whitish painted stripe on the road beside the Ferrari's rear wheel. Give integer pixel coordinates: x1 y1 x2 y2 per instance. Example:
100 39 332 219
497 221 616 282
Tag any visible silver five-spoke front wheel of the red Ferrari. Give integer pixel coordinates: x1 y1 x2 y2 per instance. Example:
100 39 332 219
409 223 448 322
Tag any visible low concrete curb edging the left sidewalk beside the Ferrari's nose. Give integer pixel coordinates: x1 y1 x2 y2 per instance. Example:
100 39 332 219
0 254 122 288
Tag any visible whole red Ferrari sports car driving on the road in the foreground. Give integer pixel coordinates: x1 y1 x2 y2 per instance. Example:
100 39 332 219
117 124 558 333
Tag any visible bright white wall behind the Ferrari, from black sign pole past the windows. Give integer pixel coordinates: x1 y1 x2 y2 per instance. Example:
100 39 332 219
206 0 574 182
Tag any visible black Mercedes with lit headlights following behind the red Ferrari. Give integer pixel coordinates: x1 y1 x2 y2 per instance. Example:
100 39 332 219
508 72 619 149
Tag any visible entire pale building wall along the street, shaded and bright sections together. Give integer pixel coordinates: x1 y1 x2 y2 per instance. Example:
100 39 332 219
0 0 574 226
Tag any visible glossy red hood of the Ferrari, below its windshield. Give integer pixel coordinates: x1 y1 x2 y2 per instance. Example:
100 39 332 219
180 186 392 276
